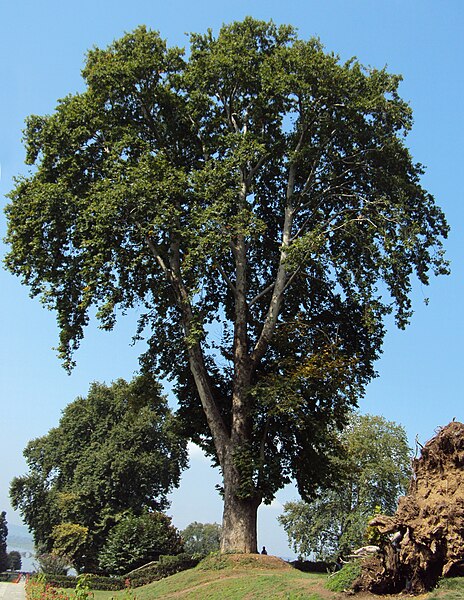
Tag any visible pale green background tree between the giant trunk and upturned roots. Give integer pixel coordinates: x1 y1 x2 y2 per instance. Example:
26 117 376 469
279 415 411 560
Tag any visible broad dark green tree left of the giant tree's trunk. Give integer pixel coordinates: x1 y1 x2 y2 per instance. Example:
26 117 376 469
11 376 187 570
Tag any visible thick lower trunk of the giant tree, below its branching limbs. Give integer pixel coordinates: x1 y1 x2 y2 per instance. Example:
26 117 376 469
221 474 260 554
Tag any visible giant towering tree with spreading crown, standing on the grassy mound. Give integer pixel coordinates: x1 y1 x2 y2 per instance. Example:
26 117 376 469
6 18 447 552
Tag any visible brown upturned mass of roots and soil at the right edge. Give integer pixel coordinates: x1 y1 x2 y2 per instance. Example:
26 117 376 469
355 422 464 594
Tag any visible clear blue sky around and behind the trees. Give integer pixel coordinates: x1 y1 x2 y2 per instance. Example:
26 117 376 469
0 0 464 556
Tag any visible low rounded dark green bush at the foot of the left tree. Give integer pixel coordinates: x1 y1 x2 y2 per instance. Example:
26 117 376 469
99 512 183 575
